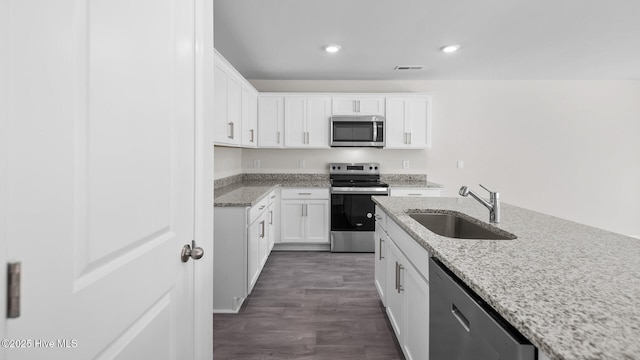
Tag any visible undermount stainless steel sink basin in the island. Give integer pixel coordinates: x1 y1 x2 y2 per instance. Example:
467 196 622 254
408 213 516 240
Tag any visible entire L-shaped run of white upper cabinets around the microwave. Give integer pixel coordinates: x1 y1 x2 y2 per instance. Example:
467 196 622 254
213 51 431 149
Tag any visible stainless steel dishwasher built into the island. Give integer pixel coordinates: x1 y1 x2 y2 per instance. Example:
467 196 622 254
429 258 536 360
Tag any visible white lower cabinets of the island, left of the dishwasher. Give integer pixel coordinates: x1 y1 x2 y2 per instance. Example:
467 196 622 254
375 210 429 360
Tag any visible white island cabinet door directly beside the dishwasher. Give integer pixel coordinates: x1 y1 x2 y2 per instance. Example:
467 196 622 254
401 263 429 360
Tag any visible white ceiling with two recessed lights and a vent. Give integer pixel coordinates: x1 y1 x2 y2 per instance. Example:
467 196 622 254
214 0 640 80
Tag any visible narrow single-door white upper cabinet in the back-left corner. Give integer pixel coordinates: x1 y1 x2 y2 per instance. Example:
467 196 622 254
258 95 284 148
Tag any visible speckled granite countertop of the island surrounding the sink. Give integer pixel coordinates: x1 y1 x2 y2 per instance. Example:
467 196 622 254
374 197 640 360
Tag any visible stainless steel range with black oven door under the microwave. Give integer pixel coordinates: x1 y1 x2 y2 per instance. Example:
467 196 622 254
329 163 389 252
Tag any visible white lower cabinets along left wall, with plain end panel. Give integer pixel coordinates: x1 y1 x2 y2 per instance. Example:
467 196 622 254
213 192 277 313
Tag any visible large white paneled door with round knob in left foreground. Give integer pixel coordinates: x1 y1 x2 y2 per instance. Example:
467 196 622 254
0 0 206 359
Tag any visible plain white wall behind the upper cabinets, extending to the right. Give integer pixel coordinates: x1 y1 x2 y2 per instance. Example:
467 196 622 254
248 80 640 236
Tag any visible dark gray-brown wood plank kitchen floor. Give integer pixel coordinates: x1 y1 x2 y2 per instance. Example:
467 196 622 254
213 252 404 360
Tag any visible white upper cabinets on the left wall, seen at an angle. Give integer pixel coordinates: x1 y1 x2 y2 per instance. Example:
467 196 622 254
213 51 258 147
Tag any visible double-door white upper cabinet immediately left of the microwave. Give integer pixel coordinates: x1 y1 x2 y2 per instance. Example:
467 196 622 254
284 96 331 148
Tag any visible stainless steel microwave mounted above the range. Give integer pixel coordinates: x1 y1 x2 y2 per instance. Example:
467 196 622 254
331 115 385 147
